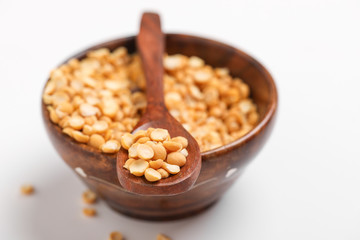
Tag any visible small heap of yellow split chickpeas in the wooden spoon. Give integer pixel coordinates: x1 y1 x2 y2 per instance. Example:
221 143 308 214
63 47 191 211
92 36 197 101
120 128 188 182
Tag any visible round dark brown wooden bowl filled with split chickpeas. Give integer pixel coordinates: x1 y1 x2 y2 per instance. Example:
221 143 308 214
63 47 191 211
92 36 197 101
42 34 278 220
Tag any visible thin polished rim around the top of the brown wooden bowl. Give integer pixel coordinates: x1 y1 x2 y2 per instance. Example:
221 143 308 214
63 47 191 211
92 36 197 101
41 33 278 161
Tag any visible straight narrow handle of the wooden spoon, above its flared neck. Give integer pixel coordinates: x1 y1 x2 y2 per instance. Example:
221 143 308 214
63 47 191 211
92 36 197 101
137 12 165 108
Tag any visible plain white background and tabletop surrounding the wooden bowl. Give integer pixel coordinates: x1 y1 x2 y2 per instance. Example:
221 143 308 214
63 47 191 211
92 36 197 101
0 0 360 240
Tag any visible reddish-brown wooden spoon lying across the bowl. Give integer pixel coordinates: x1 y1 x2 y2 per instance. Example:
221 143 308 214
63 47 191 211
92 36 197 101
117 13 201 195
